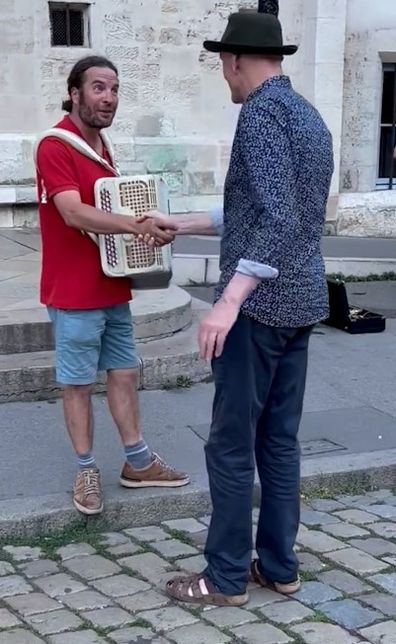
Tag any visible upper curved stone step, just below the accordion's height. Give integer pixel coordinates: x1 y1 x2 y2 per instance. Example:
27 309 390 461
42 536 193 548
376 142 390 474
0 285 192 355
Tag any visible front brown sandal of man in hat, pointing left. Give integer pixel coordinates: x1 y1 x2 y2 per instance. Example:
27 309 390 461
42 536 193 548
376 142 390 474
166 573 249 606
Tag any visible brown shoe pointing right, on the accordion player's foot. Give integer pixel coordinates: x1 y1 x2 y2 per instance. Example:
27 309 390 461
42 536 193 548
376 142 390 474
120 454 190 488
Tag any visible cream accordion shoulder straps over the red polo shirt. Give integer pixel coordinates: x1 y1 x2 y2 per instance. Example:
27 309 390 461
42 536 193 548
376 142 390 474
33 127 120 244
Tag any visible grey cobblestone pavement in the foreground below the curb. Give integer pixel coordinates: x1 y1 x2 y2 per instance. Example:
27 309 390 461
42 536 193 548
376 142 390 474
0 490 396 644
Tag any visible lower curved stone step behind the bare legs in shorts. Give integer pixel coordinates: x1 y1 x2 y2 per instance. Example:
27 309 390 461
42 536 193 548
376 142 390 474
0 302 210 403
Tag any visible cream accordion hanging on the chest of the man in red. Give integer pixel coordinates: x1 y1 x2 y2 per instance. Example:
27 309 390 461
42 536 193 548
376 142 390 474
94 175 172 289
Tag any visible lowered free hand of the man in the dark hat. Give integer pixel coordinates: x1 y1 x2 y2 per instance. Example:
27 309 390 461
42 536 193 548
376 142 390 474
198 300 239 362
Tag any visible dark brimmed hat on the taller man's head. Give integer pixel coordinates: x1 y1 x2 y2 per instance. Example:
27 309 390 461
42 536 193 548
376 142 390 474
204 10 298 56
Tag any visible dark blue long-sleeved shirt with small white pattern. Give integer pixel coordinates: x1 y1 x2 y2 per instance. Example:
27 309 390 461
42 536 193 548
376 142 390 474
216 76 334 327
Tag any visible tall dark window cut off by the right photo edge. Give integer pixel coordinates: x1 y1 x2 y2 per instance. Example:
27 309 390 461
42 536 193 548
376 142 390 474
378 63 396 190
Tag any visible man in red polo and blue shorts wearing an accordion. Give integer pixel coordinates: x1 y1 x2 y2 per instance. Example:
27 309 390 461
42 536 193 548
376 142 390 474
36 56 189 514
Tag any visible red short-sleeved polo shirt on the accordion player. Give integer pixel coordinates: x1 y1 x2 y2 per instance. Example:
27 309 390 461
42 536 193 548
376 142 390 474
37 116 131 309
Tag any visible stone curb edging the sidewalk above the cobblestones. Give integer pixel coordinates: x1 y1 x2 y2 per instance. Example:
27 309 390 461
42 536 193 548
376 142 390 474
0 449 396 539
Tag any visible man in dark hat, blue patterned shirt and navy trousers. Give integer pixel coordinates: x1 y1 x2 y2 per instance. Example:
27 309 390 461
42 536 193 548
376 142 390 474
167 11 333 606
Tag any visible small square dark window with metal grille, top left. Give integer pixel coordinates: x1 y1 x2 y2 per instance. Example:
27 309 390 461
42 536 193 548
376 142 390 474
49 2 89 47
